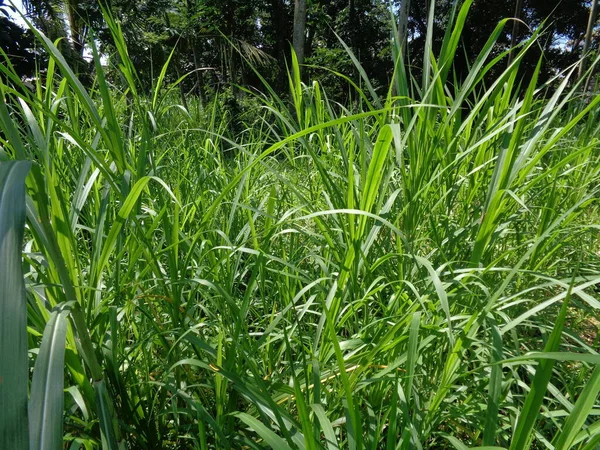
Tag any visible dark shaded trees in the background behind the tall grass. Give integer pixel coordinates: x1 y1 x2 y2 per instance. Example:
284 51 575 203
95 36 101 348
0 0 599 98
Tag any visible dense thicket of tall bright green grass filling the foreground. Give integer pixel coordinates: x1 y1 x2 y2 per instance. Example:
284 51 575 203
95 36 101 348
0 2 600 450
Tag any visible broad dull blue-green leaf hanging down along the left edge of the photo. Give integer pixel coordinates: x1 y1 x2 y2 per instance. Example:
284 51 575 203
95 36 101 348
0 161 31 450
